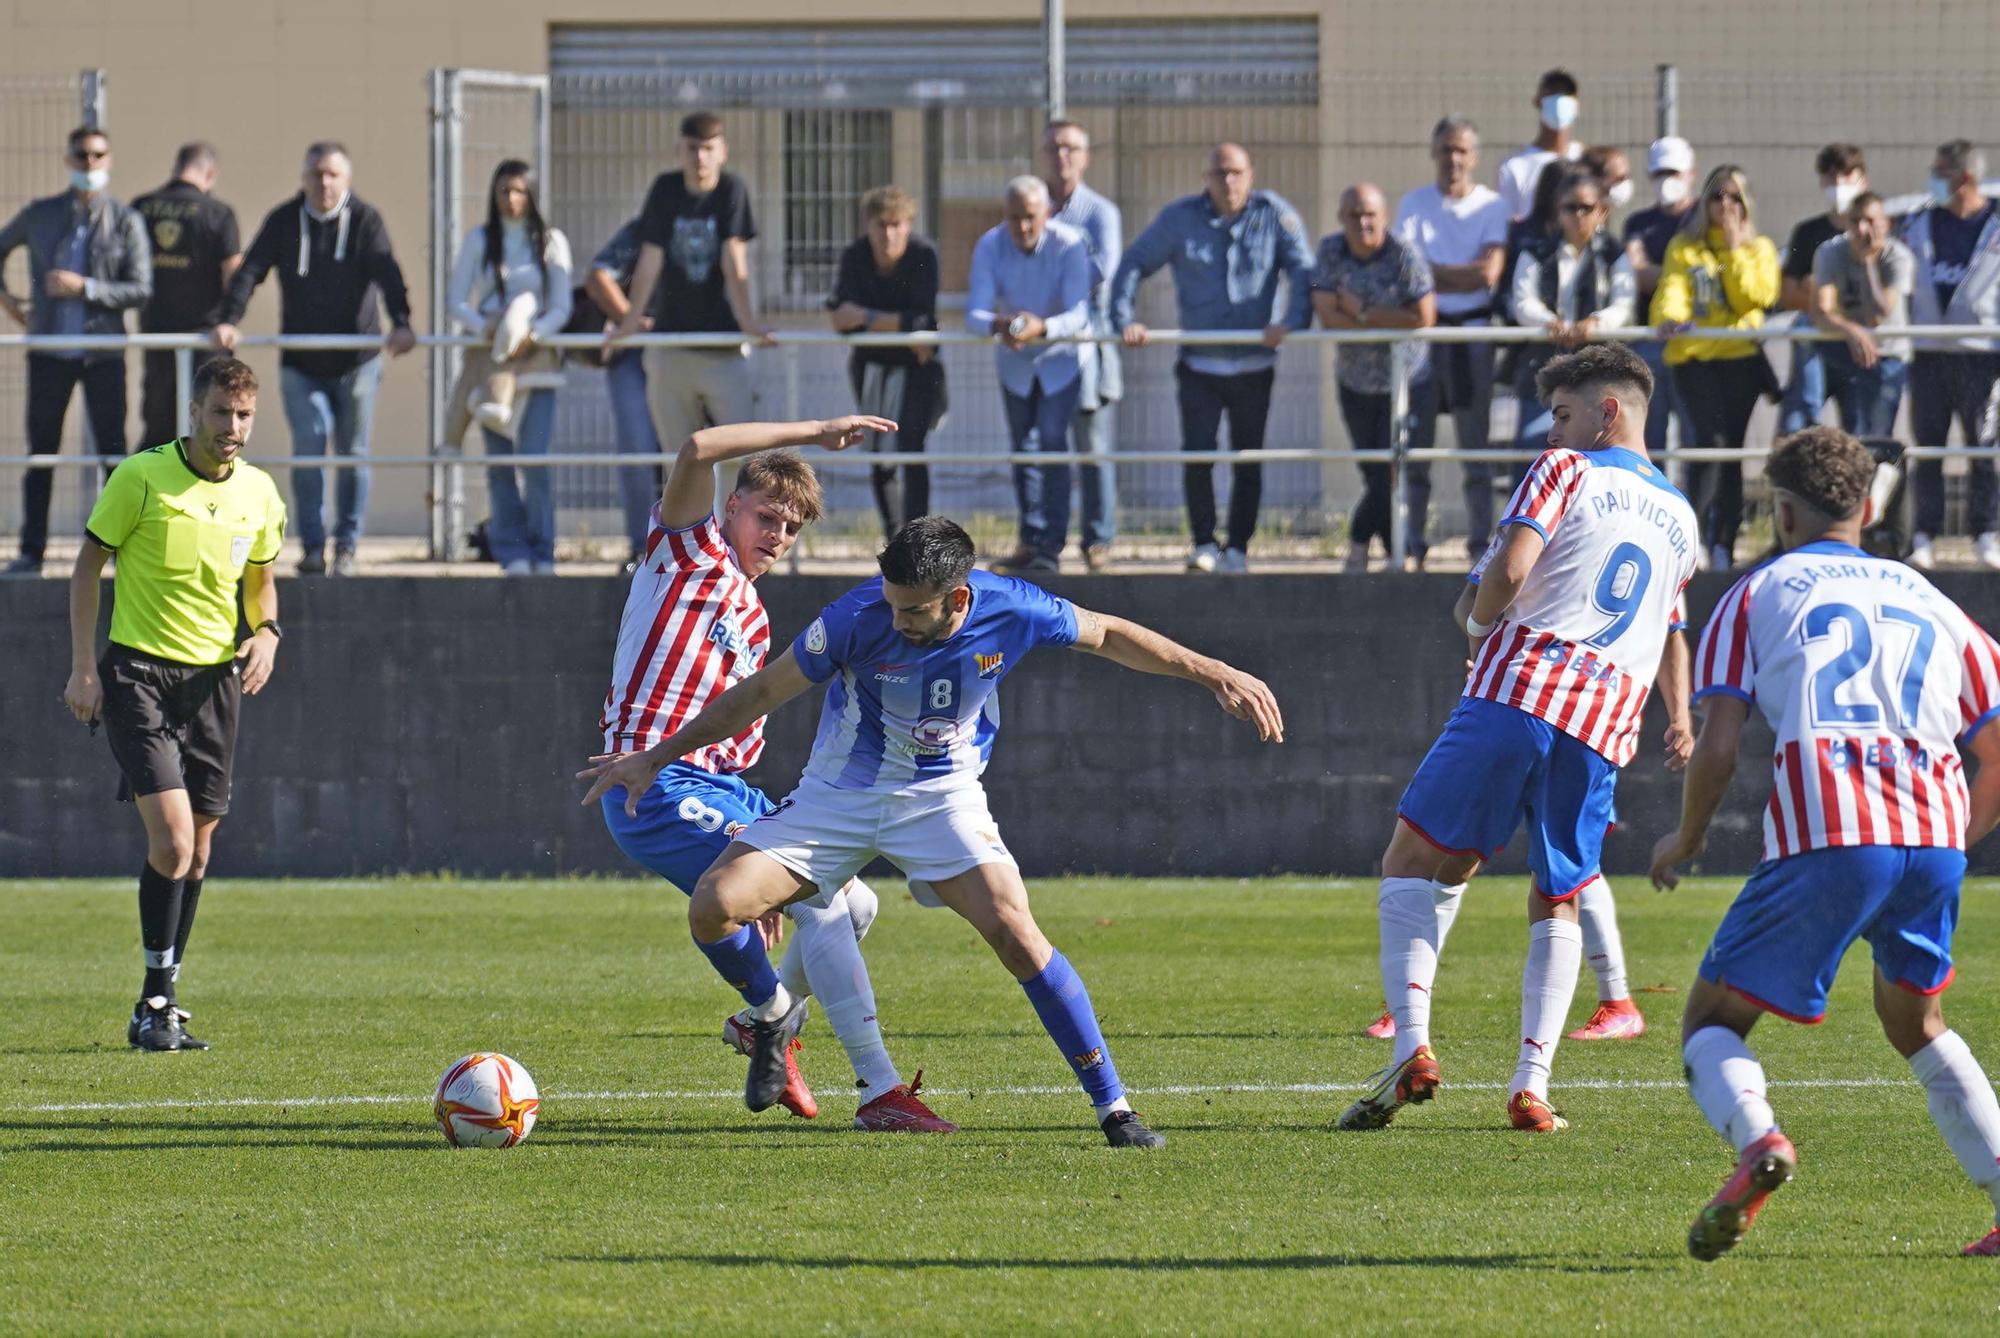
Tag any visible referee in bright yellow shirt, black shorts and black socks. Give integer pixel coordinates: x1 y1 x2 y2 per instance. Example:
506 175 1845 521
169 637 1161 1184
62 358 284 1050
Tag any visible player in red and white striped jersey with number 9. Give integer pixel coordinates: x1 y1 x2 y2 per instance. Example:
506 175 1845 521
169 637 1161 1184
1340 344 1696 1132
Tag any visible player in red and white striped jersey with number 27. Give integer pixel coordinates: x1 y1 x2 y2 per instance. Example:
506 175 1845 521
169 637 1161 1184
1652 428 2000 1258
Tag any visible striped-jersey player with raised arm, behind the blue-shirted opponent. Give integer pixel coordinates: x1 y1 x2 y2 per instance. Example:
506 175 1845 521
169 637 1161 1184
596 416 952 1130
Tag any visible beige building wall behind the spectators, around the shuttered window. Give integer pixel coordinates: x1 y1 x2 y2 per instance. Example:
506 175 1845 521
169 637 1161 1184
0 0 2000 532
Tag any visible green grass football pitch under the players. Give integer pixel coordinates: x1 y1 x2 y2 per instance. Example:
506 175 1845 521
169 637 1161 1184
0 878 2000 1334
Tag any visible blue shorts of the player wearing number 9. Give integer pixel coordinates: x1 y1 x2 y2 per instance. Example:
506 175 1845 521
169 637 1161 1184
1396 696 1618 902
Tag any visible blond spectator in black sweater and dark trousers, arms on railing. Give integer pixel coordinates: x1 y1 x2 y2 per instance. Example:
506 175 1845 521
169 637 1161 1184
826 186 944 538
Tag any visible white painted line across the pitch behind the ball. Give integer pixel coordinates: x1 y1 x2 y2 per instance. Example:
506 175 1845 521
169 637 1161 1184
12 1078 1914 1114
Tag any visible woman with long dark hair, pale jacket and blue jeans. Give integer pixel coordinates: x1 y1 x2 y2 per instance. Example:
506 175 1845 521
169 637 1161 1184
448 158 570 576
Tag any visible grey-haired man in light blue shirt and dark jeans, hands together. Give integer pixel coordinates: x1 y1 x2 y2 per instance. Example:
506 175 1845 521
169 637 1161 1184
966 176 1096 574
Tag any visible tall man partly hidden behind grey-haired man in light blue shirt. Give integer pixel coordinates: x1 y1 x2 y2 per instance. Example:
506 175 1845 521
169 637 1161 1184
1042 120 1124 572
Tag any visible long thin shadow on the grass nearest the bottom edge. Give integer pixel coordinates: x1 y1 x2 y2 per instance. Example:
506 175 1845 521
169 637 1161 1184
552 1254 1660 1274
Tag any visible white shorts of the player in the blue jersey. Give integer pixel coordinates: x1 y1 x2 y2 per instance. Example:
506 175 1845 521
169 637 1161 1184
736 776 1014 906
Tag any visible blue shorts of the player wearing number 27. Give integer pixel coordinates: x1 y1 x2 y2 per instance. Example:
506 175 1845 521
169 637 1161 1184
1702 846 1966 1022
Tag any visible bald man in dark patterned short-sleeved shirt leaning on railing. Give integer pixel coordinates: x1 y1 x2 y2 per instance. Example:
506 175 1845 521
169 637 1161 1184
1312 184 1438 572
